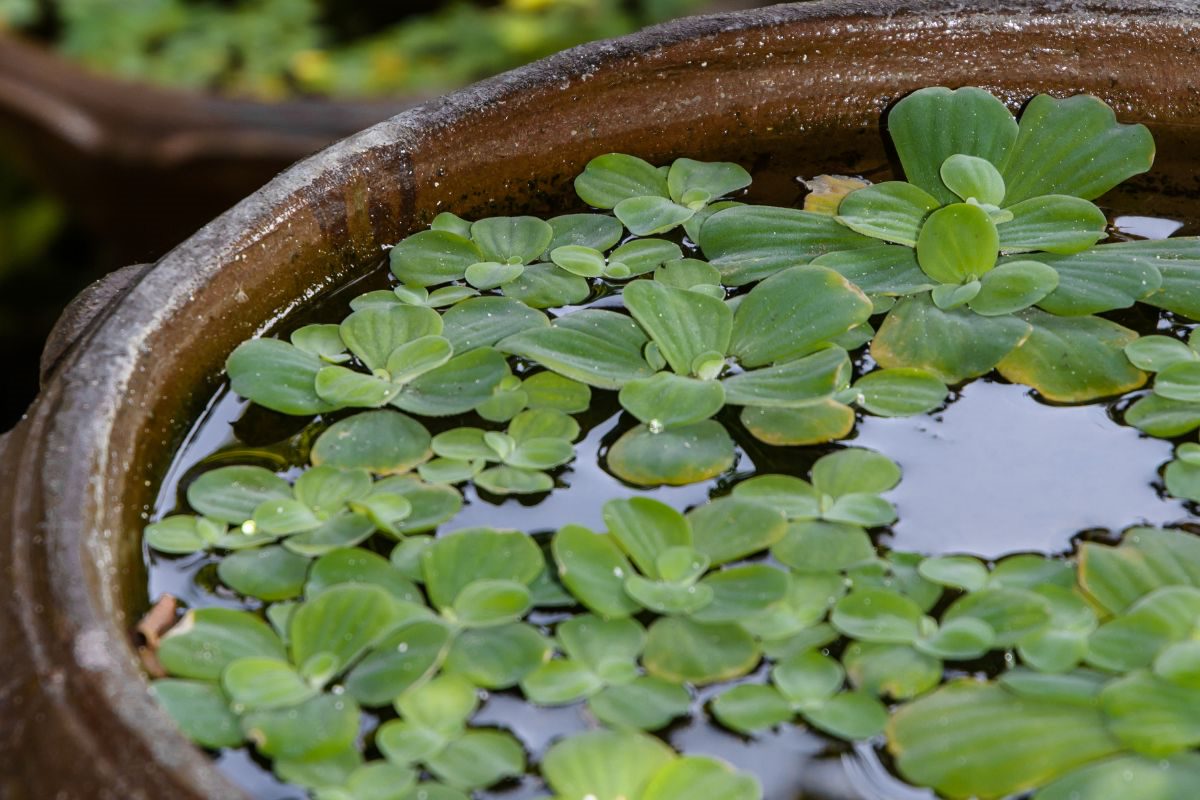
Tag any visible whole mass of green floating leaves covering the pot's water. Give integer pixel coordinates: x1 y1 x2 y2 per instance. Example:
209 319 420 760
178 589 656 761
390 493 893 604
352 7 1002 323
146 89 1200 800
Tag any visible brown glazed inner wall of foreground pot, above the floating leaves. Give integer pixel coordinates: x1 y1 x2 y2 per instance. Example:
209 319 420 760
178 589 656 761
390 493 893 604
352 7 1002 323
87 4 1200 762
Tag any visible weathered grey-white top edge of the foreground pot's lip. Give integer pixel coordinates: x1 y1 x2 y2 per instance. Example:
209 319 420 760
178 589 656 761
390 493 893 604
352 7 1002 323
8 0 1195 796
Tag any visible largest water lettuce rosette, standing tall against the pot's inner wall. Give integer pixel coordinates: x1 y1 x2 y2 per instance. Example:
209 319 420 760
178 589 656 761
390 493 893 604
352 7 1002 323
700 88 1176 402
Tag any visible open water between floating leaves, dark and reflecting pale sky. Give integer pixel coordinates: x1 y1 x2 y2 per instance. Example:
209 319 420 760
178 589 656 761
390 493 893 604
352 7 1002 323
146 199 1200 800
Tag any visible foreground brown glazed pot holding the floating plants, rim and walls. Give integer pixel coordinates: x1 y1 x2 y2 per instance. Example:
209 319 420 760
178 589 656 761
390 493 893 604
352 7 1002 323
7 0 1200 800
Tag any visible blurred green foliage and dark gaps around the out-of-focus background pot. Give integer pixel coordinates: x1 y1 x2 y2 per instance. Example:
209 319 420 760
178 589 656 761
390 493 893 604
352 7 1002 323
0 0 748 432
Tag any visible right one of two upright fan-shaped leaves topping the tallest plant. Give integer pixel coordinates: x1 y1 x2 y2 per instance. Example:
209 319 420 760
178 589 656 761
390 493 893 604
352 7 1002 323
1003 95 1154 206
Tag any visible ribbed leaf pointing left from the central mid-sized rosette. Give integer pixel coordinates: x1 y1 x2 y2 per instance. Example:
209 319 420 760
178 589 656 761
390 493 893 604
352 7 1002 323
497 309 654 389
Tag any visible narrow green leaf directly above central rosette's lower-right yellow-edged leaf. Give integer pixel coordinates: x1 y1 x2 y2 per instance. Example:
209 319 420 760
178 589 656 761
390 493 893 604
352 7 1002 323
721 345 851 408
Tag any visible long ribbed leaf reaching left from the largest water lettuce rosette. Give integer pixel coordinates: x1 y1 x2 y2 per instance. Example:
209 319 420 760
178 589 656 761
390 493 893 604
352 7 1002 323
700 205 878 285
